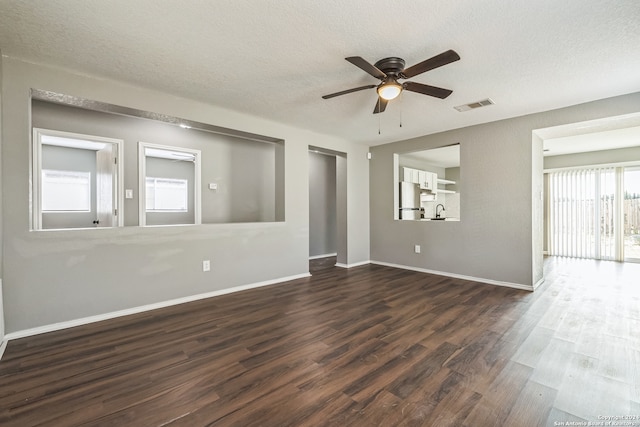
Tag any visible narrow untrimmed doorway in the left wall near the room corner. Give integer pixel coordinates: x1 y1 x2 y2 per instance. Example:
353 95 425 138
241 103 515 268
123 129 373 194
309 146 347 267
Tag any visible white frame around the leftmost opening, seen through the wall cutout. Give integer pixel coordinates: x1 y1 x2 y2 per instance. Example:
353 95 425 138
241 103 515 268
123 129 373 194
30 127 124 231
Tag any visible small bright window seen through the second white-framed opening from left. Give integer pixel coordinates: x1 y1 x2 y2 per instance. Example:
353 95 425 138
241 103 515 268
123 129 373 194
145 177 189 212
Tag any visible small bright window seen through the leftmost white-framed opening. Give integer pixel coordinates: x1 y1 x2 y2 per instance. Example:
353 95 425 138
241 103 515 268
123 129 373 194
42 169 91 212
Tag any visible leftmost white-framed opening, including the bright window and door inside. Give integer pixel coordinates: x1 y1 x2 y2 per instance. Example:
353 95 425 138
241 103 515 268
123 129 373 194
32 128 123 230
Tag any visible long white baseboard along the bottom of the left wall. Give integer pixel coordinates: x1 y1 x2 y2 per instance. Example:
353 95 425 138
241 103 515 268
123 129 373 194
5 273 311 341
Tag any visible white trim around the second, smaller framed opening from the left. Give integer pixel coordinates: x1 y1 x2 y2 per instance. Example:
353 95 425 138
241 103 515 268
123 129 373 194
138 141 202 227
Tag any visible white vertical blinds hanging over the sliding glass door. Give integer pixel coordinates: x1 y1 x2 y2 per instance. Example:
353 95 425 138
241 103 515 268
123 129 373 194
549 167 617 259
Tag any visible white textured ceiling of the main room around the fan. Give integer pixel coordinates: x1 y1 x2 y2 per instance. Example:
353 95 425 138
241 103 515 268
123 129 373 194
0 0 640 145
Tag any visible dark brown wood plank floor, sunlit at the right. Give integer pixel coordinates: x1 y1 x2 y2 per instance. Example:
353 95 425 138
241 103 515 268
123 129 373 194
0 259 640 427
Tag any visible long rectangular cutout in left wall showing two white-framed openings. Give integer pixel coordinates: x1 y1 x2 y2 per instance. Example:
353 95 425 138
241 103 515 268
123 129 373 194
31 90 285 230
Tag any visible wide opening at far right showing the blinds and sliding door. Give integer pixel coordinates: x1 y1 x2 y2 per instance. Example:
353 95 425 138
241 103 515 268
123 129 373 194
533 112 640 262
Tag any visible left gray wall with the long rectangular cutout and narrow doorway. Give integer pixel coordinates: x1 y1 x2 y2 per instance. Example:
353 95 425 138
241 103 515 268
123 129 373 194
2 57 369 333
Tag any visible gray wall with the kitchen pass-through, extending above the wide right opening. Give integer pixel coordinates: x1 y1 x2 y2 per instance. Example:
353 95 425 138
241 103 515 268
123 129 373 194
369 93 640 288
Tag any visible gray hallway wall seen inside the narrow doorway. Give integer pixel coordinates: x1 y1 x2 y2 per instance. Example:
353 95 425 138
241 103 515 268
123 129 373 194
309 152 338 257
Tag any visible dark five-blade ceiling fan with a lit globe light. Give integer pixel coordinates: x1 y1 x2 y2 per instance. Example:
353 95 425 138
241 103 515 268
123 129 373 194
322 50 460 114
